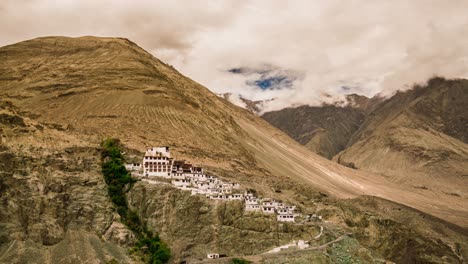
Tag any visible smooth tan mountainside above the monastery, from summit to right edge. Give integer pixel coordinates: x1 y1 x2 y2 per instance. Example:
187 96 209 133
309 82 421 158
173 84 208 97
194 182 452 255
0 37 468 226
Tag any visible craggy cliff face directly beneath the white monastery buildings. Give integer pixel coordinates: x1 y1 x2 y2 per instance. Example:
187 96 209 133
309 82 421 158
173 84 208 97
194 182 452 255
128 182 320 261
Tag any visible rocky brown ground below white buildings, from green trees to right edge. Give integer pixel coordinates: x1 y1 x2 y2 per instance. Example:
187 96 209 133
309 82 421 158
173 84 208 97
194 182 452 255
128 182 468 263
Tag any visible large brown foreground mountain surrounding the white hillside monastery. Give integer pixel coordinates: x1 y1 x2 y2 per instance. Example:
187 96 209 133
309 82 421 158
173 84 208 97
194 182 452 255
0 37 468 263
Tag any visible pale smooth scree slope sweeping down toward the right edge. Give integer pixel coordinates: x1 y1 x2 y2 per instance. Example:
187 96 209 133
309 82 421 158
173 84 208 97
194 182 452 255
236 117 468 226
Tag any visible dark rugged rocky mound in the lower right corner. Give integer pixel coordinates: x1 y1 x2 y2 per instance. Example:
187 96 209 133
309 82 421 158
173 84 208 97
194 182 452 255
337 196 468 263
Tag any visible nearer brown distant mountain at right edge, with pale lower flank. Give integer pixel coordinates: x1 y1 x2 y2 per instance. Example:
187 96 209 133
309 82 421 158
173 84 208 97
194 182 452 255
335 78 468 198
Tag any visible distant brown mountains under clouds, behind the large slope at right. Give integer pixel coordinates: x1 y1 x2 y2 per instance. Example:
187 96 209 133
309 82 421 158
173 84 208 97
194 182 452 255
262 77 468 199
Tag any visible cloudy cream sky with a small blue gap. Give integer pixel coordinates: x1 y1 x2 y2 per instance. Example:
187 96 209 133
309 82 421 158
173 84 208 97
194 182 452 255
0 0 468 110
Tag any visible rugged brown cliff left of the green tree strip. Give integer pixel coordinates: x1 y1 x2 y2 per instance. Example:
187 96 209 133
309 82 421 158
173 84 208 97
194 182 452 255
0 105 137 263
